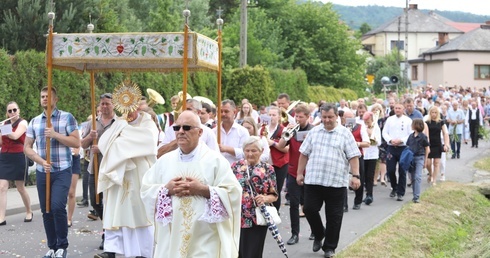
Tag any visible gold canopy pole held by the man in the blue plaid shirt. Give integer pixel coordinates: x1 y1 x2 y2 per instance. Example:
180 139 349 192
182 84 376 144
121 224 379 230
46 9 55 213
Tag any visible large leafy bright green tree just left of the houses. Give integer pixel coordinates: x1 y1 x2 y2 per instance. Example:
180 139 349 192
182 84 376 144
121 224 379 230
281 2 365 91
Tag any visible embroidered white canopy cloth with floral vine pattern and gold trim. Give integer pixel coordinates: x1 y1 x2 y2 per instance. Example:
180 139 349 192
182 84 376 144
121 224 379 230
52 32 219 72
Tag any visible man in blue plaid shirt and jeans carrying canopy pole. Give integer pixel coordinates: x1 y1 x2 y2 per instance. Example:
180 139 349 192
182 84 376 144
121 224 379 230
24 87 80 258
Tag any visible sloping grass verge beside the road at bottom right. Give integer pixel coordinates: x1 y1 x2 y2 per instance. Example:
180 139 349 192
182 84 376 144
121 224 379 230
336 181 490 258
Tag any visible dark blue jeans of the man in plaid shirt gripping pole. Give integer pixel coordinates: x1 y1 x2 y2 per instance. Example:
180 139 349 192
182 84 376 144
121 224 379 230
36 167 71 250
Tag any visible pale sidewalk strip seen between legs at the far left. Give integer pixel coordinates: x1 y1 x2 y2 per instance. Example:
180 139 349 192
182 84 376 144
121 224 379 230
5 179 82 216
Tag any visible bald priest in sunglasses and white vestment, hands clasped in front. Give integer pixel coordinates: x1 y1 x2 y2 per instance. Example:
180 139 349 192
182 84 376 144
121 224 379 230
141 111 242 258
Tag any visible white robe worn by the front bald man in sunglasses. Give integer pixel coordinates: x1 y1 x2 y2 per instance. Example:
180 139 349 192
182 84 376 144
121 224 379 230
141 143 242 258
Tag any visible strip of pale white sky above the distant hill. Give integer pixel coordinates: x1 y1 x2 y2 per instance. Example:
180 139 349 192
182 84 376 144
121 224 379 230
320 0 490 15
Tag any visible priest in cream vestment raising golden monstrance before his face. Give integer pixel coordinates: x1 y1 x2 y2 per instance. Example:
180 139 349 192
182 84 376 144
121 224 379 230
95 111 158 258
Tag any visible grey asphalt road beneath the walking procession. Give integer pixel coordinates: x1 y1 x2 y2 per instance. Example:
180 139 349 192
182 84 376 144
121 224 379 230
0 142 490 258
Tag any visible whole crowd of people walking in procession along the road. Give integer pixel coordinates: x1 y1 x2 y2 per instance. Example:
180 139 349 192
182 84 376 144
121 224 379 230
0 85 490 258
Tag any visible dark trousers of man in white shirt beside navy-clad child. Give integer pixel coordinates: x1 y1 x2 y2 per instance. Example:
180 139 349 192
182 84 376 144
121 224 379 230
386 146 407 196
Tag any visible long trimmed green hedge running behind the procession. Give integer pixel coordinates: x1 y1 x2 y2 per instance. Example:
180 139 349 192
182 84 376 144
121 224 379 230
0 50 357 122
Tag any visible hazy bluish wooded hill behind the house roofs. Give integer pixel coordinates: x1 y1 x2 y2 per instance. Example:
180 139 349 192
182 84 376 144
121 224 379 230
333 4 490 30
